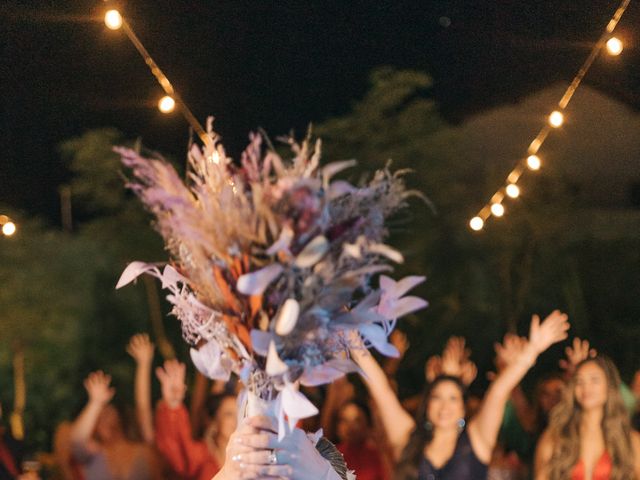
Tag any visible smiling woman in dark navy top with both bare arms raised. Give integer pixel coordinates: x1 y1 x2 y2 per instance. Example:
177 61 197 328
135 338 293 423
353 311 569 480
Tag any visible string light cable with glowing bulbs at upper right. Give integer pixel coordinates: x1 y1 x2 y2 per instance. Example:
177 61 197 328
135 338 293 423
469 0 631 231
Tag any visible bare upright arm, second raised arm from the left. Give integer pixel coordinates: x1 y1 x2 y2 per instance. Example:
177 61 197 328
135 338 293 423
127 333 154 444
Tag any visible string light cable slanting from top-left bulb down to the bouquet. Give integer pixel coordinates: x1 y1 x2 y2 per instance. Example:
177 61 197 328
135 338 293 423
105 5 217 146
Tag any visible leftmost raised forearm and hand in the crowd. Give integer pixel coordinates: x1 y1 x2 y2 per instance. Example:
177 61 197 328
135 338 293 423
71 370 116 451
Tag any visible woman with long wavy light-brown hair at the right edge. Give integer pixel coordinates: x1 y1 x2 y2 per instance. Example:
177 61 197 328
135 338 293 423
535 356 640 480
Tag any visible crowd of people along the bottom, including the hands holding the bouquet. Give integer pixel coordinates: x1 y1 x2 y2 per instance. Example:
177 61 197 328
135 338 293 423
0 311 640 480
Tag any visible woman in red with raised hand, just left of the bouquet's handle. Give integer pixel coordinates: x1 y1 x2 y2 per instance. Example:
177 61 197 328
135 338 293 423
155 360 238 480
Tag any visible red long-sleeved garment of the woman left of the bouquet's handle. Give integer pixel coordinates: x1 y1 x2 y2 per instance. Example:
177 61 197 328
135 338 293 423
155 402 220 480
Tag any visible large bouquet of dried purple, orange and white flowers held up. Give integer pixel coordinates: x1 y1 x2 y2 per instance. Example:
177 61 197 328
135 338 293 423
116 125 426 435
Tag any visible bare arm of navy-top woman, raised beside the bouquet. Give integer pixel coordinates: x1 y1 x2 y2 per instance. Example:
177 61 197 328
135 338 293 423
351 332 415 459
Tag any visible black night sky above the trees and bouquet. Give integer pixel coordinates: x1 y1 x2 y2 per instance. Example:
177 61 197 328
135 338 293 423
0 0 640 222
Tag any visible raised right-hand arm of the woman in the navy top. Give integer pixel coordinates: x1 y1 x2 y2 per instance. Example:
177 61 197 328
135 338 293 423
469 310 569 463
